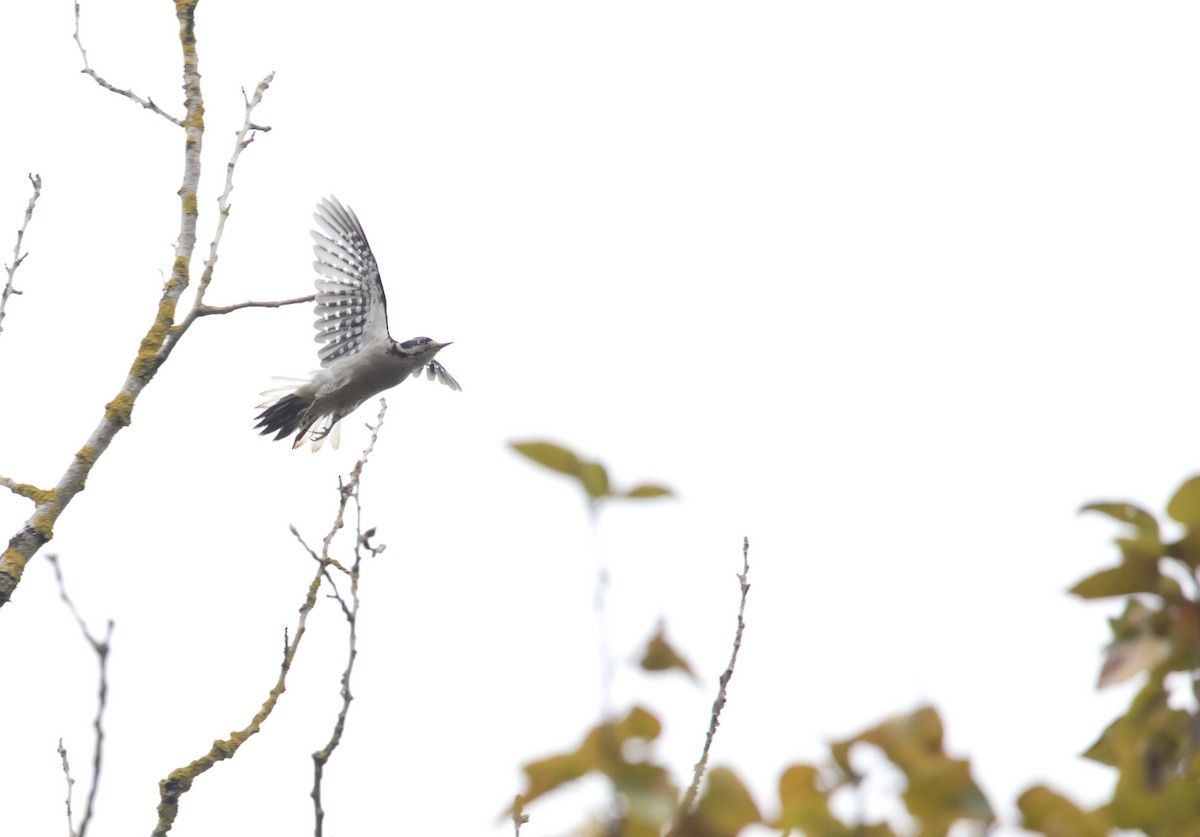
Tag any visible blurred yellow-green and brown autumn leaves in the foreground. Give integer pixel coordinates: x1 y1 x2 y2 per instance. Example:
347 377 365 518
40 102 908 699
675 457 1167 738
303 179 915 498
512 453 1200 837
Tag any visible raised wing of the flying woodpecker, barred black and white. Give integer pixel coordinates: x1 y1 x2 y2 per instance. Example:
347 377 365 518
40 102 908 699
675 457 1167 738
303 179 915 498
312 197 388 367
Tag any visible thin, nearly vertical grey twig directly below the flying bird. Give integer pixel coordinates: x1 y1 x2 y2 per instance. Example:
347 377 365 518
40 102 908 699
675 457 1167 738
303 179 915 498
310 398 388 837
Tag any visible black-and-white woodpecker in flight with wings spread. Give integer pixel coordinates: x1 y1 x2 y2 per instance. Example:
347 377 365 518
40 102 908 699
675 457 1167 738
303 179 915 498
254 197 462 451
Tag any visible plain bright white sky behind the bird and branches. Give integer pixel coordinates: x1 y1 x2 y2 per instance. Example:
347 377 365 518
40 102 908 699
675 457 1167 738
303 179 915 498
0 0 1200 837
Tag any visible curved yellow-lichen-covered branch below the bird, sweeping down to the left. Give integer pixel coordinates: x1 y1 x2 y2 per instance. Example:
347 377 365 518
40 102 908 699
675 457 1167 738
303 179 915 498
152 399 388 837
